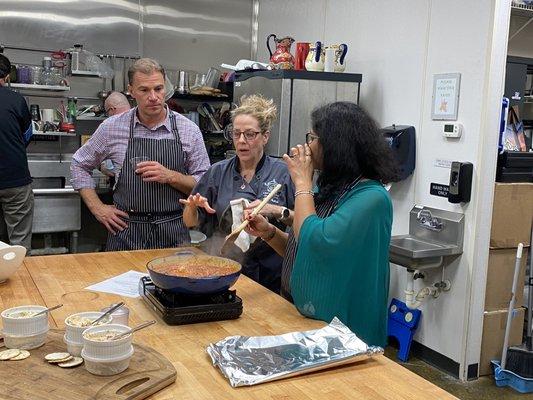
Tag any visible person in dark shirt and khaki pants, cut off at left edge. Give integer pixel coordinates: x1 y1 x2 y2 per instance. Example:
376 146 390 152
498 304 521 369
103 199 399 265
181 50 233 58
0 54 33 251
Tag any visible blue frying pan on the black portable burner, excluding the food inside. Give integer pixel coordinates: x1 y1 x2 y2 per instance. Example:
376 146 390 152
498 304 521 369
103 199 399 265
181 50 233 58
146 250 241 295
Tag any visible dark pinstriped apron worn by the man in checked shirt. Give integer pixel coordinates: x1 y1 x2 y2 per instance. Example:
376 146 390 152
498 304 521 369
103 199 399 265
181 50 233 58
106 110 190 251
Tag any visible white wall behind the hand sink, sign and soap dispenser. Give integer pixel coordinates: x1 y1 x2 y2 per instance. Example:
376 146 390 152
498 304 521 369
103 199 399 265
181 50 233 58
258 0 509 374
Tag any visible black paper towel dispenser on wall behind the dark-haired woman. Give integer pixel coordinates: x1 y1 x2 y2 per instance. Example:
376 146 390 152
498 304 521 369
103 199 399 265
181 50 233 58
381 125 416 182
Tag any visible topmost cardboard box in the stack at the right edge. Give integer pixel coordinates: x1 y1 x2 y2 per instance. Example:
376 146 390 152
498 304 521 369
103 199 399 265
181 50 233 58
490 183 533 248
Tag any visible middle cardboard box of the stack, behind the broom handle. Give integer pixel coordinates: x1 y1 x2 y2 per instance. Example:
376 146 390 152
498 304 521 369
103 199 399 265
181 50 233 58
485 248 529 311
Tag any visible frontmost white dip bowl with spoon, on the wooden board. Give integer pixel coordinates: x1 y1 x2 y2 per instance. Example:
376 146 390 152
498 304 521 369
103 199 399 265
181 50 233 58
81 324 134 375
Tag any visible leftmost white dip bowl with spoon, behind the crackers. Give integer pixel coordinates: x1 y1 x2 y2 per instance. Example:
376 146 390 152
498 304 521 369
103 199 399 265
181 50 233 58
1 305 49 350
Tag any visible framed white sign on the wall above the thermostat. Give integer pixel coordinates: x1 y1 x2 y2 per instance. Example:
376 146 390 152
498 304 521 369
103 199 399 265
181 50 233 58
431 74 461 121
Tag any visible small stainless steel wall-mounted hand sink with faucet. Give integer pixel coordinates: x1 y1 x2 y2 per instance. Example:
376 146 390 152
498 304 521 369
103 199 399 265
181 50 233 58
389 206 464 269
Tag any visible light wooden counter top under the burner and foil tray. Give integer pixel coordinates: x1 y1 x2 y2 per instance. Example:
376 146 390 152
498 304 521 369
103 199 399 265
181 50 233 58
0 249 455 400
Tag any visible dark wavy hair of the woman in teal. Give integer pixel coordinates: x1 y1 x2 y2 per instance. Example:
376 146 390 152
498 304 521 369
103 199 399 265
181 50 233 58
311 101 397 203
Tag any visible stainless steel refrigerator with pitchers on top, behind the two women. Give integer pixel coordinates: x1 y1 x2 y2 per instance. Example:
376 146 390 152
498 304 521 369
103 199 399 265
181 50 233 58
234 70 362 157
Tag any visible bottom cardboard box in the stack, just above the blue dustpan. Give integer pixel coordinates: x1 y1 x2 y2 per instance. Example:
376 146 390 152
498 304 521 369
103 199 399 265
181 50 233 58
479 307 525 376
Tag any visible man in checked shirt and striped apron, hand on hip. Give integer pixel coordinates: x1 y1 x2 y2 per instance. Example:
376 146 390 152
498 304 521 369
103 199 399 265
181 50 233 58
71 58 210 251
